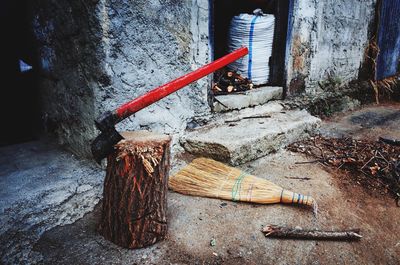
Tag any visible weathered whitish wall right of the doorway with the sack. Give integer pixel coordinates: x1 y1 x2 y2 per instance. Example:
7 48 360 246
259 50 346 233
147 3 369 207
287 0 376 94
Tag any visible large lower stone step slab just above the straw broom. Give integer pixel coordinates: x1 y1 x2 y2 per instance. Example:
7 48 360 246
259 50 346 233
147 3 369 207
181 110 321 165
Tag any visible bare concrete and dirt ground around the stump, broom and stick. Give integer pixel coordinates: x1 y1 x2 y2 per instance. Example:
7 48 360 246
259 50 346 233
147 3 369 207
0 102 400 264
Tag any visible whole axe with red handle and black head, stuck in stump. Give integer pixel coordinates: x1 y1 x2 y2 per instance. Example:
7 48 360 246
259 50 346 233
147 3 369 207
91 47 248 163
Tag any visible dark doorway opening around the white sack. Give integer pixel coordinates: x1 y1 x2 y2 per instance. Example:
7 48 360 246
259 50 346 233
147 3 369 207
211 0 290 86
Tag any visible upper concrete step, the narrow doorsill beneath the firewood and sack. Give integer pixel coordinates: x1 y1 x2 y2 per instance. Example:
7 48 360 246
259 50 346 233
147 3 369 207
214 86 283 112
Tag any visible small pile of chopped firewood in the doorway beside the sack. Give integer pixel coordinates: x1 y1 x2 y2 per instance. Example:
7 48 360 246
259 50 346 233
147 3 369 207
212 70 253 95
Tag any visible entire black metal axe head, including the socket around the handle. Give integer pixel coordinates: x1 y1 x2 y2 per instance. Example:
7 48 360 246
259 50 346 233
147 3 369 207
91 112 124 164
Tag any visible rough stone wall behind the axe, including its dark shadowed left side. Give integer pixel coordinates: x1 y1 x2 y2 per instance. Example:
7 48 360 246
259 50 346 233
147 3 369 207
31 0 209 156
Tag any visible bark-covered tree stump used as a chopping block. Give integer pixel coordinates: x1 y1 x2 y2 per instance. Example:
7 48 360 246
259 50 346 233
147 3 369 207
99 131 171 248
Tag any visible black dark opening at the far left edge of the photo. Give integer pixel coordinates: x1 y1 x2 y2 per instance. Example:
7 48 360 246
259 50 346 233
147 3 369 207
0 0 41 146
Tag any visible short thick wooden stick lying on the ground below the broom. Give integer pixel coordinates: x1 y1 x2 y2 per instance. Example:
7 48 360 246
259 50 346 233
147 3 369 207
262 225 362 241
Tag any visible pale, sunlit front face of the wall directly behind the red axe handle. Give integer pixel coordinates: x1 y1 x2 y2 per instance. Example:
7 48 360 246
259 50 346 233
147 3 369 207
96 0 209 133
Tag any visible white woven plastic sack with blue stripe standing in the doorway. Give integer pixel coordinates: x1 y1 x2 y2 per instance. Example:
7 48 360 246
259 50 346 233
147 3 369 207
228 9 275 85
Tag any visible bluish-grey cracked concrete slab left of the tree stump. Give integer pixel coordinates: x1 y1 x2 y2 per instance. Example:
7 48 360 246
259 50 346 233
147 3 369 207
0 140 103 264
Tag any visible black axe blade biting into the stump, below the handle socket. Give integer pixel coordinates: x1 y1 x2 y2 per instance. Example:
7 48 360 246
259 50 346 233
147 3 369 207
91 127 124 164
